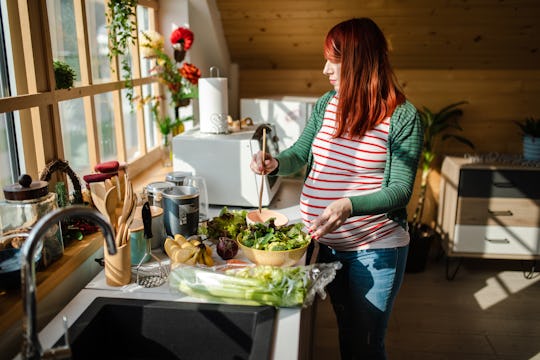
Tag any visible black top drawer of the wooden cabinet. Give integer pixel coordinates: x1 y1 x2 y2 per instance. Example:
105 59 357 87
458 169 540 199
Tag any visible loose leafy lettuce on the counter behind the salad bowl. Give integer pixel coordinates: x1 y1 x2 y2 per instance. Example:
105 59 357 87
199 206 247 240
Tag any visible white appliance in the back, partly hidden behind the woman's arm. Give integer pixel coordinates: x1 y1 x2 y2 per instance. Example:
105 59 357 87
240 96 317 150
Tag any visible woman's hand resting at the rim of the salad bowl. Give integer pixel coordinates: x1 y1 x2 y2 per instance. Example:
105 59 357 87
308 198 352 240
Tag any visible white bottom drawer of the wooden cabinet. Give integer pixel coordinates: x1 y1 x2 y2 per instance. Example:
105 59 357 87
452 225 540 255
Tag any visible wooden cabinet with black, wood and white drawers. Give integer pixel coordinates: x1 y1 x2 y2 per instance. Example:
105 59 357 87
437 157 540 278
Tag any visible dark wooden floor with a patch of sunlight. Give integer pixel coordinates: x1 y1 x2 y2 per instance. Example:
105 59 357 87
312 246 540 360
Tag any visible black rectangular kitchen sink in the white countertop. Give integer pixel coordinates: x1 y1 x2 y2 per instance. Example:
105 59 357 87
55 297 277 360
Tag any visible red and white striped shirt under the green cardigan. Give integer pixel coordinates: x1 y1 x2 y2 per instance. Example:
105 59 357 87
300 96 408 251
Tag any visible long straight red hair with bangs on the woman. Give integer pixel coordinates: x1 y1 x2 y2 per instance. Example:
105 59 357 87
324 18 405 137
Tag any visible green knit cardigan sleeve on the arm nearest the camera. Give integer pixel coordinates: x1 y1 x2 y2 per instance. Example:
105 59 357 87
350 102 424 216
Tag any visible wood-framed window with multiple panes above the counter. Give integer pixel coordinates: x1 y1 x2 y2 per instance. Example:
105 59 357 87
0 0 162 196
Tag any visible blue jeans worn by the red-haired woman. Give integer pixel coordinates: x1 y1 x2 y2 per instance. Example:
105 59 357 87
319 244 409 360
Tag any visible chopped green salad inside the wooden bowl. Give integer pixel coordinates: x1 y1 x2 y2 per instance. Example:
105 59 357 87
236 221 311 251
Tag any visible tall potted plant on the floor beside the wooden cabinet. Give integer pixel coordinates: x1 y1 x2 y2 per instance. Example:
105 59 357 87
406 101 474 272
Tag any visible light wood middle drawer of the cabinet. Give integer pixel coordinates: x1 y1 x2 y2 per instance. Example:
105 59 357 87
456 197 540 227
